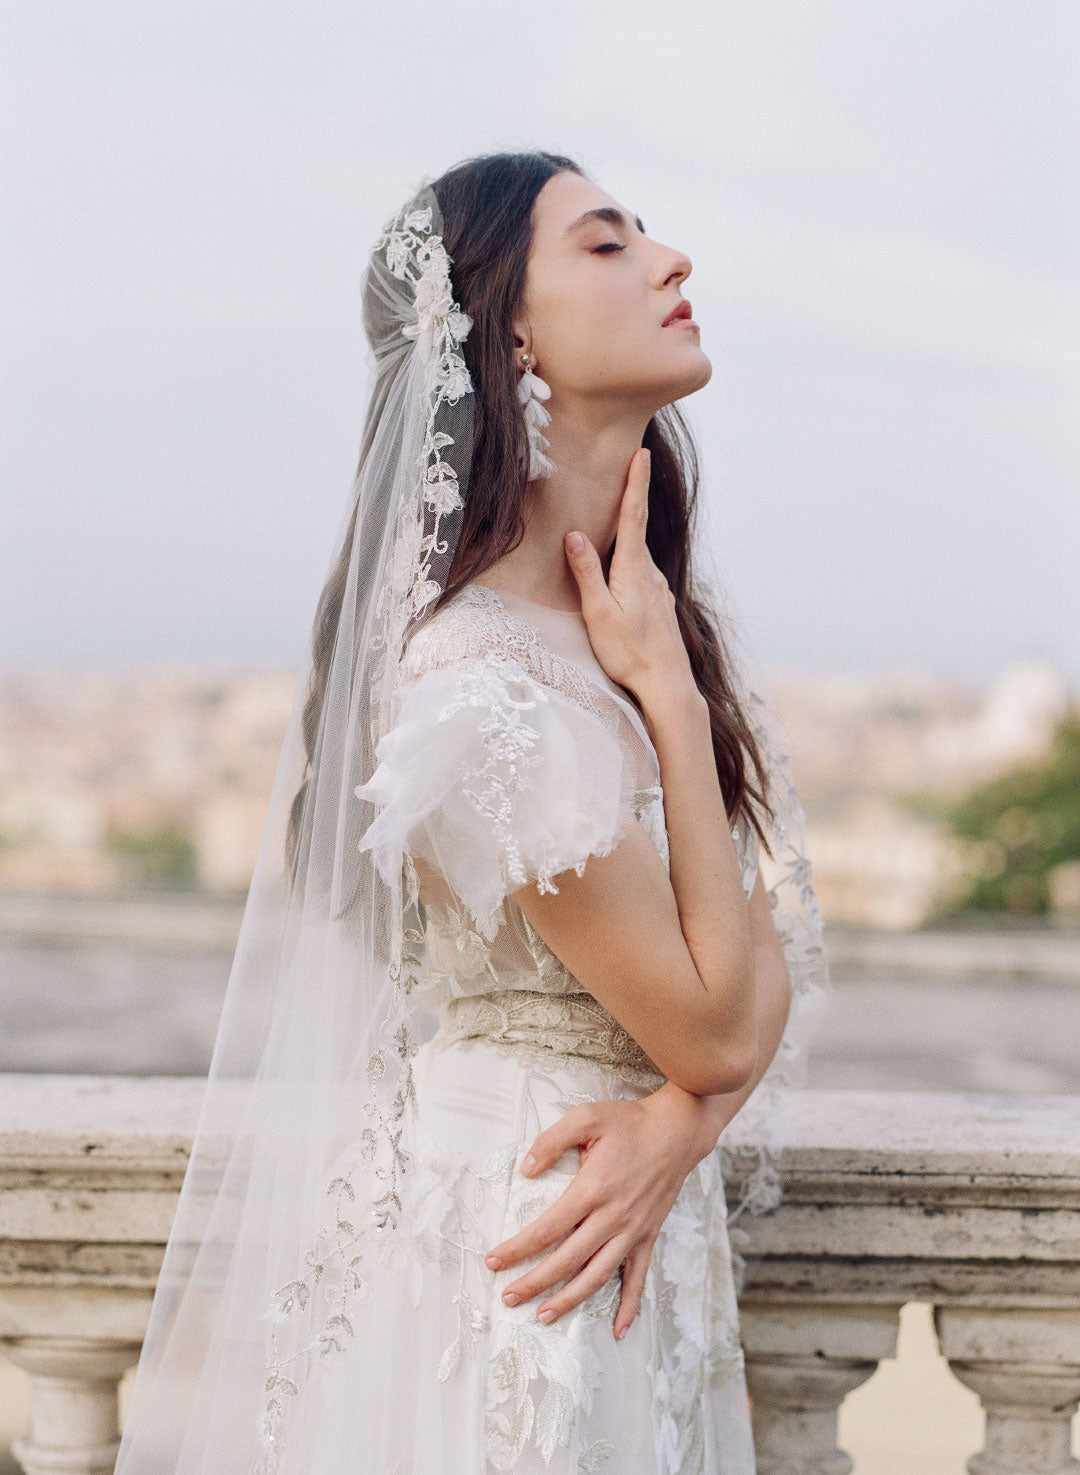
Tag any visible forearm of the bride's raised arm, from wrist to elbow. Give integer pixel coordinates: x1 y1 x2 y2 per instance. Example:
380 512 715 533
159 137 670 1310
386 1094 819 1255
642 686 755 1046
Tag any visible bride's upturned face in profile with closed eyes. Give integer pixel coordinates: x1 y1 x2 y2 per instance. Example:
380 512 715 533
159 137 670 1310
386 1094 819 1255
513 170 713 417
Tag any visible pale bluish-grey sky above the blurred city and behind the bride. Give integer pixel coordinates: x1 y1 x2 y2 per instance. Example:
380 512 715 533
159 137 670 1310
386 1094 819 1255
0 0 1080 683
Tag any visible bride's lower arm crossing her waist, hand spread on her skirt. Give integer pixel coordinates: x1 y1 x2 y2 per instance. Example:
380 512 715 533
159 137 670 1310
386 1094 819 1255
487 876 791 1338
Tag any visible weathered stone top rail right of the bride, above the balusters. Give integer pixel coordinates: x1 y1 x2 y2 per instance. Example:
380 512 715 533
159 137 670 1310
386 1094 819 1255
730 1092 1080 1304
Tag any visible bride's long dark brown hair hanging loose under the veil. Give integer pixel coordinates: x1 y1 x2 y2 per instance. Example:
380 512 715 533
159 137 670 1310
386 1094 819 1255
286 150 772 873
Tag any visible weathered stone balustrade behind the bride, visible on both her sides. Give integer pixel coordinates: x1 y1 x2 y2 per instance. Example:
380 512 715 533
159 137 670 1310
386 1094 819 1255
0 1075 1080 1475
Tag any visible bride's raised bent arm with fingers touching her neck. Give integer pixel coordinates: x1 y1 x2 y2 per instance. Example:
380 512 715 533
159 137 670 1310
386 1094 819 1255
513 451 758 1094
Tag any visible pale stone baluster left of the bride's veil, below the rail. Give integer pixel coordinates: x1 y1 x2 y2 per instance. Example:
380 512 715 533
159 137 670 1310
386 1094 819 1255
4 1336 139 1475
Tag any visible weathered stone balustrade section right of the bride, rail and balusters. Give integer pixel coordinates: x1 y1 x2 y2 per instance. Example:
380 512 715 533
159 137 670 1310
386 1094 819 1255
725 1092 1080 1475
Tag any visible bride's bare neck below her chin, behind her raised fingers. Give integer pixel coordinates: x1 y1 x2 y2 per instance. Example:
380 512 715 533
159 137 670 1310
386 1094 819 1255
484 404 654 608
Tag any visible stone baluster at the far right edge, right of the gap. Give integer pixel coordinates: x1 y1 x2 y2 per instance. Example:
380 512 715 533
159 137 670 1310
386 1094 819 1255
934 1305 1080 1475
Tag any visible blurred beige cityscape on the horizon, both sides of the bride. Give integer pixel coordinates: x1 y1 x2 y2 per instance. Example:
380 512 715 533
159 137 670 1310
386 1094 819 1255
0 658 1080 929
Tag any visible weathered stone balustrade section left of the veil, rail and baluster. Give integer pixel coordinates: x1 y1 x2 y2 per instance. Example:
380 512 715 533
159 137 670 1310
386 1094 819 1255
0 1075 202 1475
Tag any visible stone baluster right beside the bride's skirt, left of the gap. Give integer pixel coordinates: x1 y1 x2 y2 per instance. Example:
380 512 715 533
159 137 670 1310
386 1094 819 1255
741 1298 900 1475
